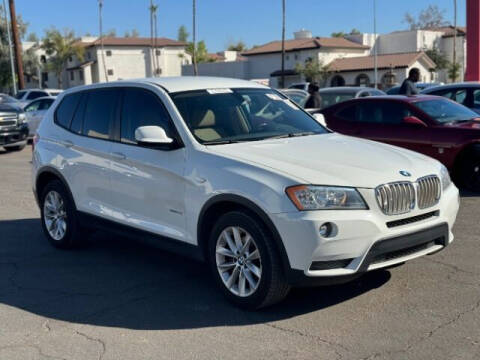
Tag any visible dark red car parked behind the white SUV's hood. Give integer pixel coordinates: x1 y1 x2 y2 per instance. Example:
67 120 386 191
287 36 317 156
320 95 480 191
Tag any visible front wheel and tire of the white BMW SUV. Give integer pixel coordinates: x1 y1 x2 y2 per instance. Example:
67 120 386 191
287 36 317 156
208 211 290 310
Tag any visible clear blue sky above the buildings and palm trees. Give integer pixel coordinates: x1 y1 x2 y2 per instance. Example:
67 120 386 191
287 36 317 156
16 0 465 52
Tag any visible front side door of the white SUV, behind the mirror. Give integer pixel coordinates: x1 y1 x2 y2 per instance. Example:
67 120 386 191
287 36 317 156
110 87 186 240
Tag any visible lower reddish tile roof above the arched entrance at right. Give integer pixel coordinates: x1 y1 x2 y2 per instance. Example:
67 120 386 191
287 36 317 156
329 51 436 71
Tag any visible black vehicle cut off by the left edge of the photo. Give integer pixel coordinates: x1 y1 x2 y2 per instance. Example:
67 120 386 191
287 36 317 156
0 104 28 151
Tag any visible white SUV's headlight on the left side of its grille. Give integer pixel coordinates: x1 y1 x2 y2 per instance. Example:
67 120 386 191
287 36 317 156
286 185 368 211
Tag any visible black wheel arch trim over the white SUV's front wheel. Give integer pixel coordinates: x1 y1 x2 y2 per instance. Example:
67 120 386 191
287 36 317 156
197 194 290 274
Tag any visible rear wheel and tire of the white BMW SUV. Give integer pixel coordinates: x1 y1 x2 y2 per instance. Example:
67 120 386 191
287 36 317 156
40 180 84 249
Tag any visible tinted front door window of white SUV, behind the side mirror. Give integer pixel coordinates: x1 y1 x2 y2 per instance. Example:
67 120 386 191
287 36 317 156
120 88 173 144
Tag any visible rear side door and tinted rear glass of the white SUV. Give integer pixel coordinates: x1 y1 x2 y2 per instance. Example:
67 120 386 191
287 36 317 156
55 87 120 218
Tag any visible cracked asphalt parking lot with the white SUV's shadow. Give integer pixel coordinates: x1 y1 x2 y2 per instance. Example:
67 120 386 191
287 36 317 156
0 147 480 360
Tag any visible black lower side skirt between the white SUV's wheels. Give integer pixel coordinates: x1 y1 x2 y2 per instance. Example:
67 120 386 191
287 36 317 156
77 211 205 261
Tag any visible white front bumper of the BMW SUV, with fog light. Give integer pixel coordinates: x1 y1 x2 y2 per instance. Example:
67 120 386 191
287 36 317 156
270 185 459 285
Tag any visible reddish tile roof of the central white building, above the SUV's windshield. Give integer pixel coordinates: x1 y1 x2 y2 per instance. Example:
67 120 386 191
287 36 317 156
242 37 369 56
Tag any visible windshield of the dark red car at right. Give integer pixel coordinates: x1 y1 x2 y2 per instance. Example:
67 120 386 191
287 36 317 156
415 99 478 123
